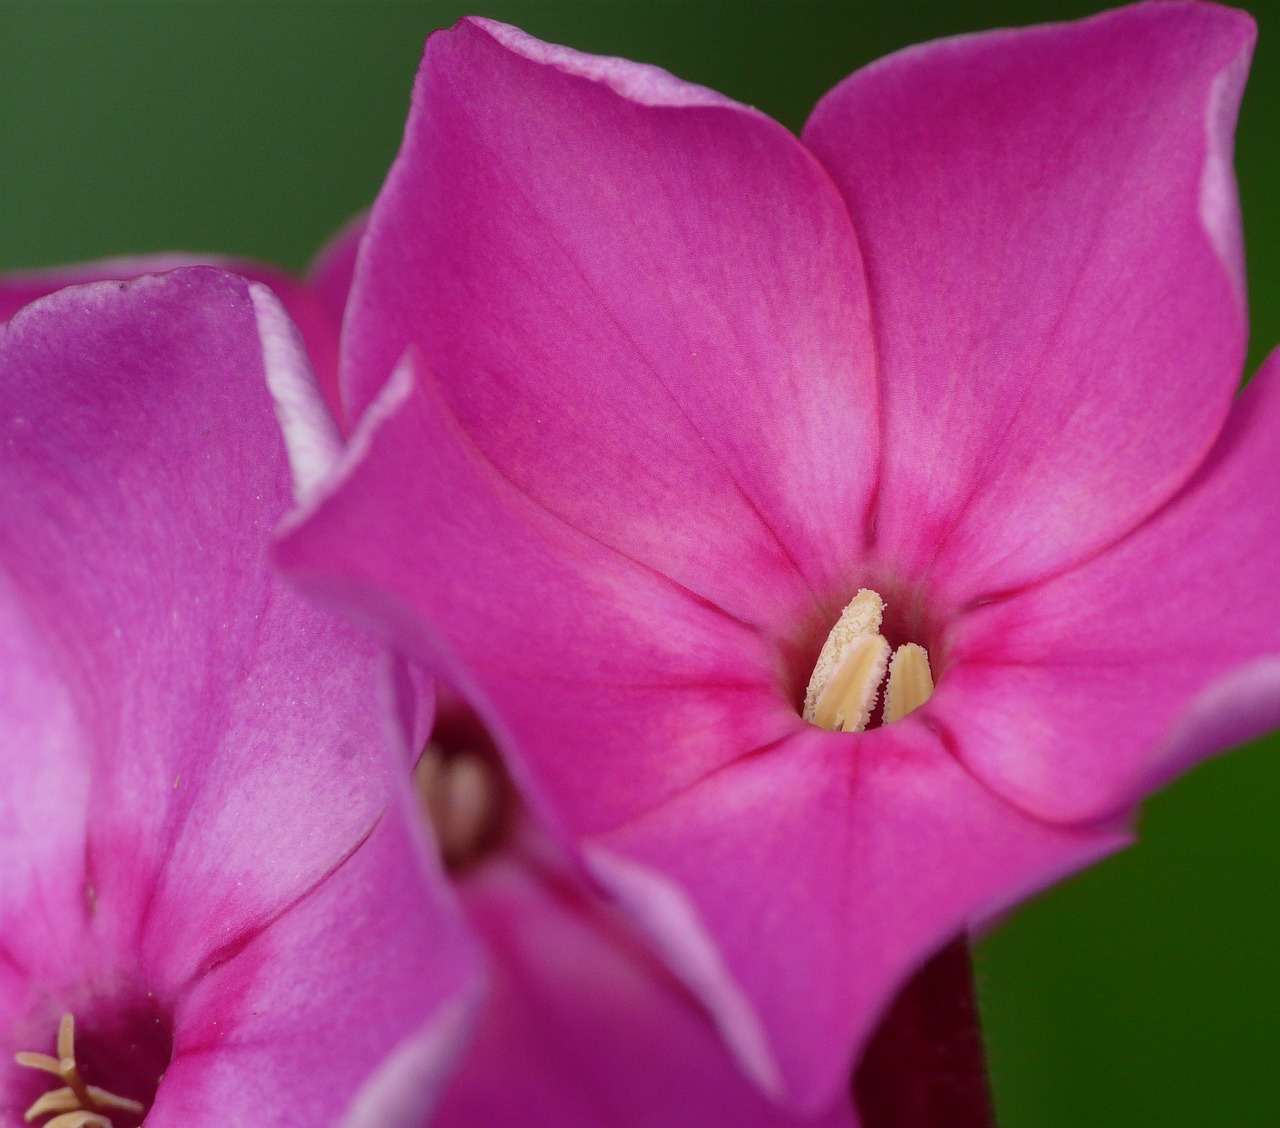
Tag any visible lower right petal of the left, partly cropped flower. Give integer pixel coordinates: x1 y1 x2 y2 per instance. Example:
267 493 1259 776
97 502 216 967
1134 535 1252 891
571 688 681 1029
147 788 479 1128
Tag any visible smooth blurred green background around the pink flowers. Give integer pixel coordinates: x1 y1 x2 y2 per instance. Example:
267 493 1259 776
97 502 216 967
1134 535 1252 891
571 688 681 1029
0 0 1280 1128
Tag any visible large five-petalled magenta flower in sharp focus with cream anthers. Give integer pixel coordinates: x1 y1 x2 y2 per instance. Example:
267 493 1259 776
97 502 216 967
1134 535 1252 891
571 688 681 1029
280 4 1280 1109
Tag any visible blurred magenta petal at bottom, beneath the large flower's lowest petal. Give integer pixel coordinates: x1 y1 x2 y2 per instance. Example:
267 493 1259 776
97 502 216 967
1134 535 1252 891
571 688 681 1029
431 857 856 1128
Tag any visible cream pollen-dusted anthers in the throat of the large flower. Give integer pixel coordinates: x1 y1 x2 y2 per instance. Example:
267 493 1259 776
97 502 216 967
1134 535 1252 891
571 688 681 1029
804 588 933 732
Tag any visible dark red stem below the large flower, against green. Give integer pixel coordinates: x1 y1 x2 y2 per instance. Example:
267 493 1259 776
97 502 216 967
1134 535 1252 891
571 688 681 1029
854 936 996 1128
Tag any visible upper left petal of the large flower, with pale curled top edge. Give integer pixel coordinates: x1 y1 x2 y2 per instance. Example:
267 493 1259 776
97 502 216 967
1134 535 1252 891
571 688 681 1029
343 20 878 632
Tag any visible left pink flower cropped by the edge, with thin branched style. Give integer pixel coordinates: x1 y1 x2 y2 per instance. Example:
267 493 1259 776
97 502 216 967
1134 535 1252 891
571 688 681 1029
0 269 475 1128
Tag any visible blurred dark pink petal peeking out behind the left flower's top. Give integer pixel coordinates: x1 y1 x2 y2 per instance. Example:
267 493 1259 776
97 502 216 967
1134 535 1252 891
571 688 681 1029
0 250 351 414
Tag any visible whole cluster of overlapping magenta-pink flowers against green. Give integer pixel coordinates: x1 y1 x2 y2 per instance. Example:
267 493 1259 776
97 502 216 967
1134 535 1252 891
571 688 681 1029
0 3 1280 1128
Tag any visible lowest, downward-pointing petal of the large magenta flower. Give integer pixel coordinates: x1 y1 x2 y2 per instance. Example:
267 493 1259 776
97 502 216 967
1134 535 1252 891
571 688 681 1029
585 721 1128 1109
